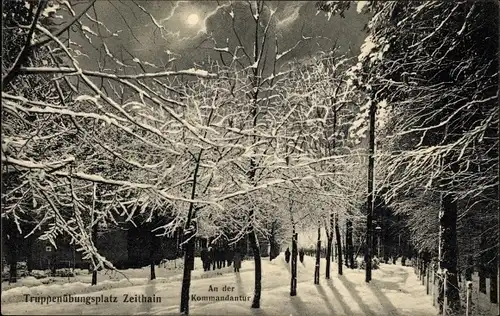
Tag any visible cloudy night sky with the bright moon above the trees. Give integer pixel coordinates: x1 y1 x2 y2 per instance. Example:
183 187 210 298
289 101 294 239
71 0 368 69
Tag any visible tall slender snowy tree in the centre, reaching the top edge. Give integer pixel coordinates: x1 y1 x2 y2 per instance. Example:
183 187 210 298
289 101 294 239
204 1 320 308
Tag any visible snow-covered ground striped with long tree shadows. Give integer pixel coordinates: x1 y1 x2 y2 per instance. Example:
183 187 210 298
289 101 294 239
2 256 436 316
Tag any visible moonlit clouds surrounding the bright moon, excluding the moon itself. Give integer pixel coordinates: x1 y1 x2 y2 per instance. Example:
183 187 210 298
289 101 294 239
116 1 366 67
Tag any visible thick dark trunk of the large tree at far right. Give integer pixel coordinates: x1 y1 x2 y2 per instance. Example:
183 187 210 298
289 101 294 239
439 193 460 311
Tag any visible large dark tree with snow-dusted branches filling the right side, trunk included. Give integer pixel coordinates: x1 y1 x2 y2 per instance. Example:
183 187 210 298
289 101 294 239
319 1 498 310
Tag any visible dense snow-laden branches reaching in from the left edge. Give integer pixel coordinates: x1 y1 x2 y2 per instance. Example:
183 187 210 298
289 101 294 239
2 1 221 284
